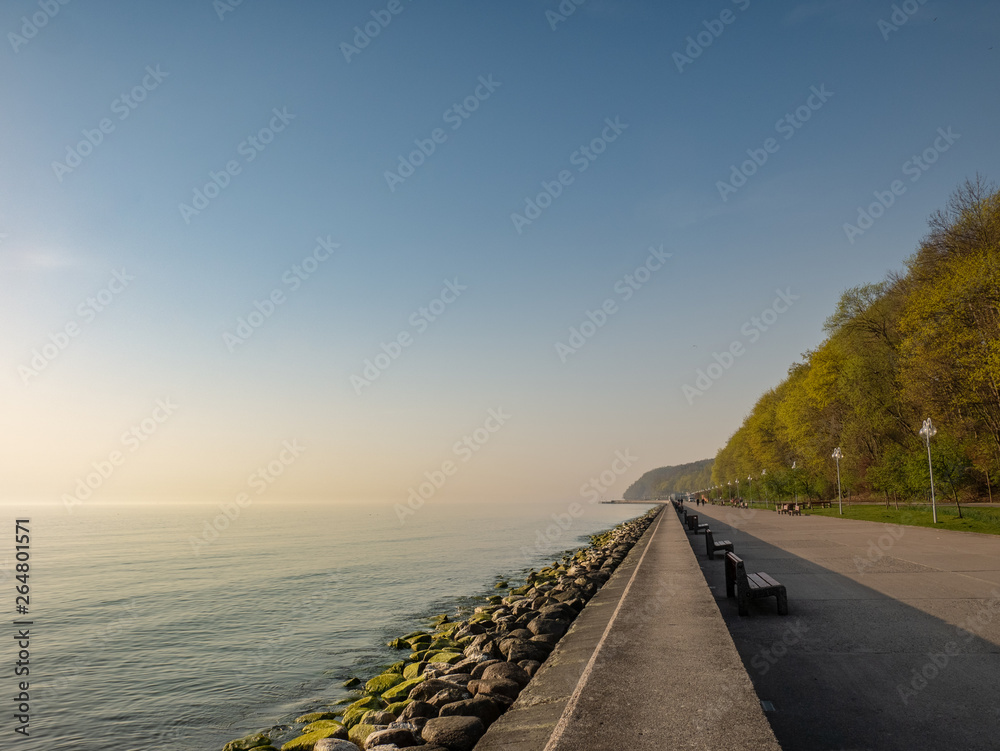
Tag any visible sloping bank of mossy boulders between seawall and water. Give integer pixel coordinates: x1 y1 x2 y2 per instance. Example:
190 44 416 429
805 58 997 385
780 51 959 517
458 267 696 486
223 510 656 751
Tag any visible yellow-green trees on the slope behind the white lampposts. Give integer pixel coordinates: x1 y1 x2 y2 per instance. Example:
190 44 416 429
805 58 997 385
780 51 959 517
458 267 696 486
711 177 1000 504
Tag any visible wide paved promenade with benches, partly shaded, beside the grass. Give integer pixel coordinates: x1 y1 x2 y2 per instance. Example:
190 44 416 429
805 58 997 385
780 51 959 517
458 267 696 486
688 506 1000 751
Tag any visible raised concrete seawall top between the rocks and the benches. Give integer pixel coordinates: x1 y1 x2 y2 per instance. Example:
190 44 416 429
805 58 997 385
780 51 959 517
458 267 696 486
476 506 787 751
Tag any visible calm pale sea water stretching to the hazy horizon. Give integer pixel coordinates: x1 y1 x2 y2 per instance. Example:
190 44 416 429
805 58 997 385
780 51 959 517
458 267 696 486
0 503 649 751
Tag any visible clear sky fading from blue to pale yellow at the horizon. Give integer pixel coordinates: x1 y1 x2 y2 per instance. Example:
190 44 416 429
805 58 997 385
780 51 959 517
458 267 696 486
0 0 1000 504
